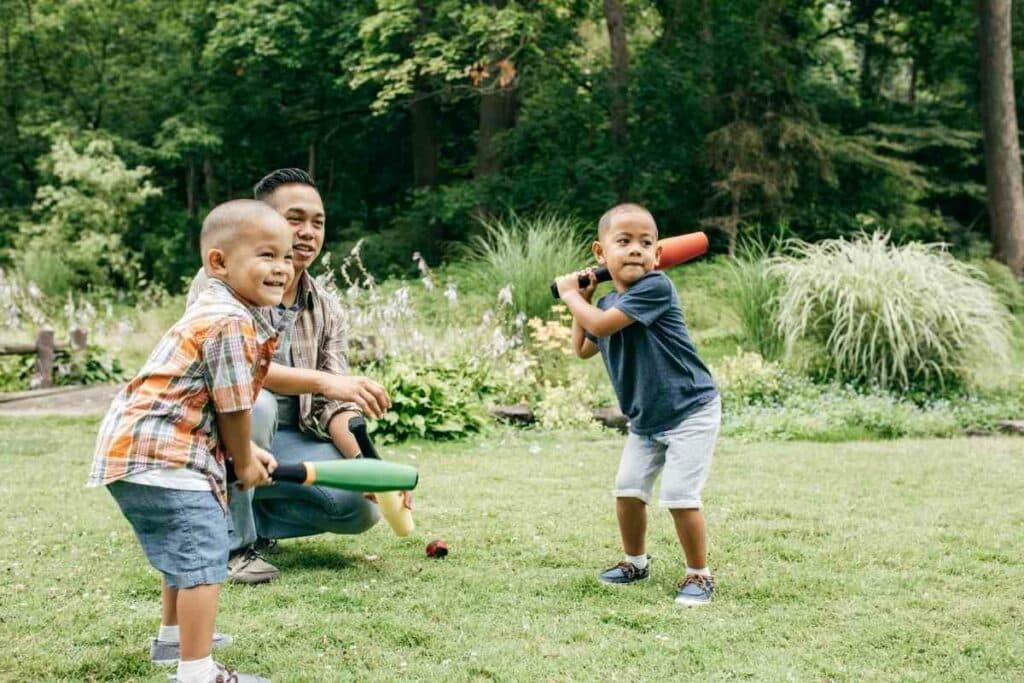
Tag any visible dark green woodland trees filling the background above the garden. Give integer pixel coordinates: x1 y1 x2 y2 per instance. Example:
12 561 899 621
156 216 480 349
0 0 1007 287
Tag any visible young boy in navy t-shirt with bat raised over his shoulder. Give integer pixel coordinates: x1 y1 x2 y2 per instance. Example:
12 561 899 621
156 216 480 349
557 204 722 606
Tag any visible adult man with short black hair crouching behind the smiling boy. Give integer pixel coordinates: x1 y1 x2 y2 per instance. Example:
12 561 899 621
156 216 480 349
188 169 401 584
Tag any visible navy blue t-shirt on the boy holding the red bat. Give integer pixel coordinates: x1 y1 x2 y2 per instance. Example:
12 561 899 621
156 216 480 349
587 270 718 435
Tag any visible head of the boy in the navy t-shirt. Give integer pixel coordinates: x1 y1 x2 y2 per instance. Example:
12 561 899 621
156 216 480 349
592 210 662 291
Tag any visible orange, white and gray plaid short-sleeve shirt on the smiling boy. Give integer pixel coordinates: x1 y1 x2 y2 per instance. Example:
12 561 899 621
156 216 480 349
88 280 295 495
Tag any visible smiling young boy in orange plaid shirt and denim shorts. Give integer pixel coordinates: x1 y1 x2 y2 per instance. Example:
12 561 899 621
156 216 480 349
89 200 294 683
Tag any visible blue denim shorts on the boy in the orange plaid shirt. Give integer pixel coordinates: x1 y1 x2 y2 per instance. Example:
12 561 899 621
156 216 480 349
106 481 227 588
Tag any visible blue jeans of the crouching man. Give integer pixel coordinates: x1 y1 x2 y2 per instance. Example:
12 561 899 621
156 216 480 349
227 390 380 551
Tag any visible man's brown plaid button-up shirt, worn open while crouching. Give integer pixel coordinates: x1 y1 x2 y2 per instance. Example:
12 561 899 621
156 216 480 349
188 270 359 440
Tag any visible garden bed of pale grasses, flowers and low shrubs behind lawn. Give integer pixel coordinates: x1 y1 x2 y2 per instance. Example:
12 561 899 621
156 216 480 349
8 217 1024 442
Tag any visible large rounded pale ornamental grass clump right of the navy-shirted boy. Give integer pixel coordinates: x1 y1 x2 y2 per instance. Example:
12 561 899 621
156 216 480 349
769 233 1009 391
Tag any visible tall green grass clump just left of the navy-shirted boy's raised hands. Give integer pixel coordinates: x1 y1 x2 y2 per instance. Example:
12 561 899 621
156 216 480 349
461 214 592 317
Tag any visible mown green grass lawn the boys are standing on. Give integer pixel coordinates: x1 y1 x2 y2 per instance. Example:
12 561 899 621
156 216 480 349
0 419 1024 681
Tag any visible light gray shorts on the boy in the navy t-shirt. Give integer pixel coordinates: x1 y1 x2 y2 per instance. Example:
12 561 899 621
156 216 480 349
614 396 722 509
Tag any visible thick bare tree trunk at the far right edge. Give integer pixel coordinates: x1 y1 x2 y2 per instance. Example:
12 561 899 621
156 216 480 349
978 0 1024 278
